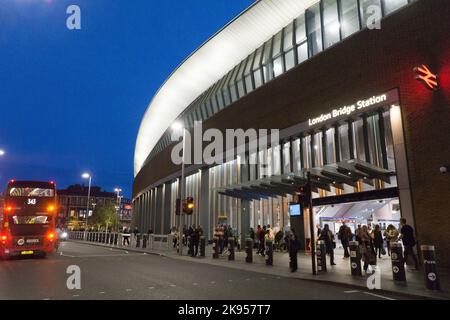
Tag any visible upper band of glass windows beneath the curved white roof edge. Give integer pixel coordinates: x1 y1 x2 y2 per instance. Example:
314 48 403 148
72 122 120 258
148 0 415 159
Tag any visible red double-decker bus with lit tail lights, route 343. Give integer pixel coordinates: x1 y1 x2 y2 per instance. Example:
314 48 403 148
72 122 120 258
0 180 58 258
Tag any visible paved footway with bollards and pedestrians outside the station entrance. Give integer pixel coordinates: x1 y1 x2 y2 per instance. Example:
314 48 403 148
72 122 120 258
67 235 450 300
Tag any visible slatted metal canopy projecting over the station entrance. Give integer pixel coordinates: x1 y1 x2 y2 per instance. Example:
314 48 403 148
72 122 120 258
216 160 395 201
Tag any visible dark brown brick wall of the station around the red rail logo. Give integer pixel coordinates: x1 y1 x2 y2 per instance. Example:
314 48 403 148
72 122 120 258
134 0 450 267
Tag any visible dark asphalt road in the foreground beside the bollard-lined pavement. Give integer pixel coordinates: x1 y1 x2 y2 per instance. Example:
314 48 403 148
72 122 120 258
0 242 414 300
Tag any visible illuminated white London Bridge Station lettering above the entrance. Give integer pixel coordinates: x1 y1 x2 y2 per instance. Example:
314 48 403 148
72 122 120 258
308 93 391 127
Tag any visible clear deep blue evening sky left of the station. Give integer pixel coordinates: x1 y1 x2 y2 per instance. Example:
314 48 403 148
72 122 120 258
0 0 254 196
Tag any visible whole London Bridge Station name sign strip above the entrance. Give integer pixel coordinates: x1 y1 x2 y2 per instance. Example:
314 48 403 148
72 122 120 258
308 89 399 127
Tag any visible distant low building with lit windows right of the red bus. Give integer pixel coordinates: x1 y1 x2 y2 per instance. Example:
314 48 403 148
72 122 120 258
58 184 117 225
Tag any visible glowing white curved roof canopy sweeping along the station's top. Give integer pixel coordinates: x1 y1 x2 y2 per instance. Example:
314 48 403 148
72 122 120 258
134 0 319 176
